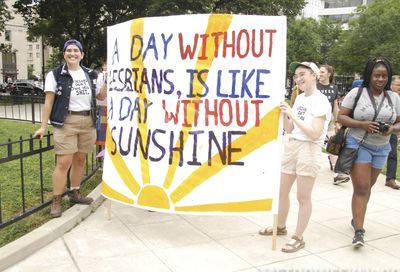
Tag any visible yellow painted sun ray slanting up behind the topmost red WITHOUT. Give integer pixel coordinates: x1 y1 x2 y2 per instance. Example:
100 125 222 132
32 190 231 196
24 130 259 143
163 14 233 189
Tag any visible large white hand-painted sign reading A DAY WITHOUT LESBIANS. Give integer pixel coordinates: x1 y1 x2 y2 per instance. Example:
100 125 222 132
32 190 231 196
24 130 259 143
102 14 286 214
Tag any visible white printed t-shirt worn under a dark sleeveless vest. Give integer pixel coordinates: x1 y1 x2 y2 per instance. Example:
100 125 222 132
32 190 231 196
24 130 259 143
45 68 98 111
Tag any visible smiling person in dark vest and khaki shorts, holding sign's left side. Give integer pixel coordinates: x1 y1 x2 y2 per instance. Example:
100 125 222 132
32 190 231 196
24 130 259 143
34 39 107 217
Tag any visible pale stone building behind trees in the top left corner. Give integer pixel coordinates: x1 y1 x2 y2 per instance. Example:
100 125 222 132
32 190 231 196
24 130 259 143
0 0 52 83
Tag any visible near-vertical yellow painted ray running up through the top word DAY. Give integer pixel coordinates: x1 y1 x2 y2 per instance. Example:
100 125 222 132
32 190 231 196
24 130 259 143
130 18 150 184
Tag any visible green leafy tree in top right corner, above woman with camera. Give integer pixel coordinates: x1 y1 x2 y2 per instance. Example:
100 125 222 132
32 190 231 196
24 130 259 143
329 0 400 74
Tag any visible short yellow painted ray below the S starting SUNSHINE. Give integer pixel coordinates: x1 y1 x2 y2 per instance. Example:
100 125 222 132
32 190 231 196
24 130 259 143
106 126 140 195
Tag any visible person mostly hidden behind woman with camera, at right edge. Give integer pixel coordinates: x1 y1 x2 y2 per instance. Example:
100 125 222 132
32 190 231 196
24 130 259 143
385 75 400 190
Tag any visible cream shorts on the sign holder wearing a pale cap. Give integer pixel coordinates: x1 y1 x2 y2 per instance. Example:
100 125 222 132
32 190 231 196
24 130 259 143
281 138 322 177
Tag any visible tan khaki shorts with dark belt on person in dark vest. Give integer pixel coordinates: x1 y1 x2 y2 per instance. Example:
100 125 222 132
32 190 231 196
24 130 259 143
54 115 96 155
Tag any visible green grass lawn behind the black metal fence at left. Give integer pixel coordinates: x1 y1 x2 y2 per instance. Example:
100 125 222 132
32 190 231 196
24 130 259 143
0 120 101 247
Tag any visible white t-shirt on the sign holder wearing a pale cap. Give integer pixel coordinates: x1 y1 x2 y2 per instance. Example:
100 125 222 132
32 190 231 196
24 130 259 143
292 91 332 146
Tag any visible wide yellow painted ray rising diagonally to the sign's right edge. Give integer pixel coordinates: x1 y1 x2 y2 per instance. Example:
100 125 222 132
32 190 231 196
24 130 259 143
170 107 280 203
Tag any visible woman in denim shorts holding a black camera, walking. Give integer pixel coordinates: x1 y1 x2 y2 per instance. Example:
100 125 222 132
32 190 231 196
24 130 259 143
338 57 400 248
